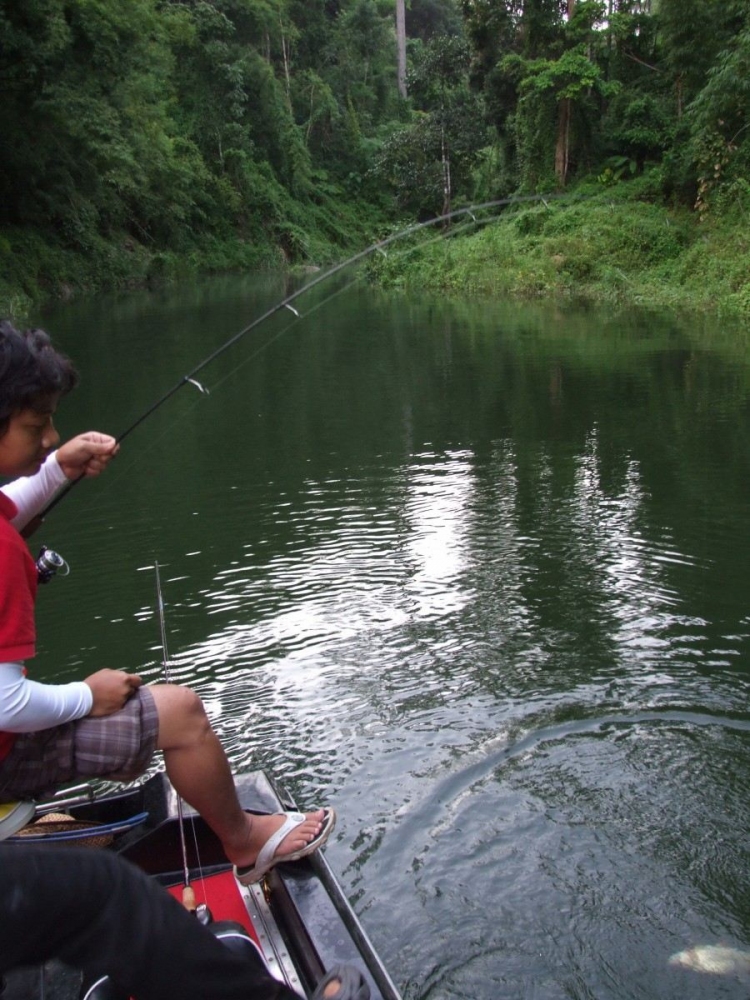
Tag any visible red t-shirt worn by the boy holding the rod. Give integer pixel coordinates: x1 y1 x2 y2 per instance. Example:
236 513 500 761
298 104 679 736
0 490 37 760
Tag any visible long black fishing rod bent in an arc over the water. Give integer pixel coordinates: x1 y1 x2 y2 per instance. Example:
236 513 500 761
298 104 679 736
30 194 570 535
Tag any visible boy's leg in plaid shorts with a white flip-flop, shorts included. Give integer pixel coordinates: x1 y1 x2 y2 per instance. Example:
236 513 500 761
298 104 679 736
0 671 336 882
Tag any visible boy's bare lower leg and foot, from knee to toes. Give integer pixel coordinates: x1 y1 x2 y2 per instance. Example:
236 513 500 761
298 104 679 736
149 684 324 867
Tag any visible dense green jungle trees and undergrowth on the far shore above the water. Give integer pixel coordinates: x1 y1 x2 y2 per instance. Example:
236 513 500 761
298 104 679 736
0 0 750 313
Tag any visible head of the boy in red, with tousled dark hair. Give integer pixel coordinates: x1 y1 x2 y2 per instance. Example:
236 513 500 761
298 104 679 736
0 320 78 476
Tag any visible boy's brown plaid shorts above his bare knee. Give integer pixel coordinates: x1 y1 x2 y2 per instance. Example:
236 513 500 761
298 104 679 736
0 687 159 802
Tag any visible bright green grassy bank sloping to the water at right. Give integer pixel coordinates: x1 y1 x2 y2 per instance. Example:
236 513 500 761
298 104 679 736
372 194 750 317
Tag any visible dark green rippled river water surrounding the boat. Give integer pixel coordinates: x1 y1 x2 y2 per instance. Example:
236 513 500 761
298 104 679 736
26 277 750 1000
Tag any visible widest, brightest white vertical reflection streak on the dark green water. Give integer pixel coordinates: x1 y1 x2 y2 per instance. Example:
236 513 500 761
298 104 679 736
406 451 474 618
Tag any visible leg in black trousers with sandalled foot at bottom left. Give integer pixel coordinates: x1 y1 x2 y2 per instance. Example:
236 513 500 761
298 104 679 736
0 844 369 1000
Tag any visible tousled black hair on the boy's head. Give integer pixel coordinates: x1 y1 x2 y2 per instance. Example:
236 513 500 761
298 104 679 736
0 320 78 435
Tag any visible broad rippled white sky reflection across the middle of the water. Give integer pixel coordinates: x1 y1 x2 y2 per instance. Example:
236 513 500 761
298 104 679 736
162 429 748 720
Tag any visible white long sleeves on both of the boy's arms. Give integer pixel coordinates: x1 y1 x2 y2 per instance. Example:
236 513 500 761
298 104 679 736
0 452 94 733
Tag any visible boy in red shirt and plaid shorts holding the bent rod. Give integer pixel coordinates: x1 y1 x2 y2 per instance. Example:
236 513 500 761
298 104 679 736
0 321 335 884
